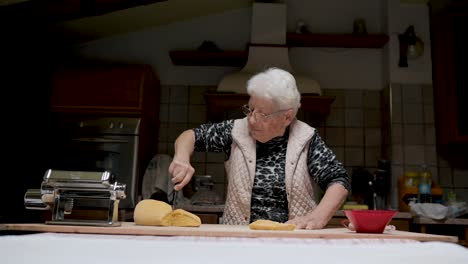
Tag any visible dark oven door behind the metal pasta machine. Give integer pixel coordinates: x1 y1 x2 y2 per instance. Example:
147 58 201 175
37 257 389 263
49 135 138 209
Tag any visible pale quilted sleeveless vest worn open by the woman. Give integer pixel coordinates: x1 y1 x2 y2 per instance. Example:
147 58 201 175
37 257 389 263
223 118 318 225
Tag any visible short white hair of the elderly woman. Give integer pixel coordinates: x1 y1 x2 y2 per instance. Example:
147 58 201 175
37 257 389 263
247 67 301 114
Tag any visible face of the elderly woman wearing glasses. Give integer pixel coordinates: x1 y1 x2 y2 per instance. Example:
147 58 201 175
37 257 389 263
247 96 293 143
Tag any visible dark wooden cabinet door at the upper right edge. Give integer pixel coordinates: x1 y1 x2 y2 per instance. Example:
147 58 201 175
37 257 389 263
431 11 468 146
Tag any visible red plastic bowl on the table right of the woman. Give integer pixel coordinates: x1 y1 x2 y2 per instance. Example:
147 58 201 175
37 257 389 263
344 210 398 233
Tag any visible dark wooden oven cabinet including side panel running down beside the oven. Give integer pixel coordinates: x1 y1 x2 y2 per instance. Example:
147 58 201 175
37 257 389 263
50 63 160 198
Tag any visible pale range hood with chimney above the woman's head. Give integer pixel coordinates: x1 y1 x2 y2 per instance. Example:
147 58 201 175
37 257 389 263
217 3 322 95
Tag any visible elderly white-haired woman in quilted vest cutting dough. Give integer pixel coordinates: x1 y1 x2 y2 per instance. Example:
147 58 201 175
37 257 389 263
169 68 350 229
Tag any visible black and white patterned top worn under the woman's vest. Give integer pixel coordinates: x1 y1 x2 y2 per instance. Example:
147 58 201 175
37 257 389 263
193 120 351 223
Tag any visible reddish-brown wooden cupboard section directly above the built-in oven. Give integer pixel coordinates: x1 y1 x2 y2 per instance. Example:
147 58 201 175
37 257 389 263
50 64 159 114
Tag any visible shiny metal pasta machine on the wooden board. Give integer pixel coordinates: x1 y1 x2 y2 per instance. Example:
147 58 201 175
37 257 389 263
24 169 126 226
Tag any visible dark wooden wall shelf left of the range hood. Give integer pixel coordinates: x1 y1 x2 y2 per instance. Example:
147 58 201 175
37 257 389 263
169 50 248 67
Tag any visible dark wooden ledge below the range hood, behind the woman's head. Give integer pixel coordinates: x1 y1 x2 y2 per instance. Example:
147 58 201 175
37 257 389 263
205 92 335 123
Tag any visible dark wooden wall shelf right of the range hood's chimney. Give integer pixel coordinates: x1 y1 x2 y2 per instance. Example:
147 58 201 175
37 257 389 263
286 33 389 49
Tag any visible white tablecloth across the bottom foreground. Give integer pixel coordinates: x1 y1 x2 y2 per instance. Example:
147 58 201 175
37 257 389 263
0 233 468 264
